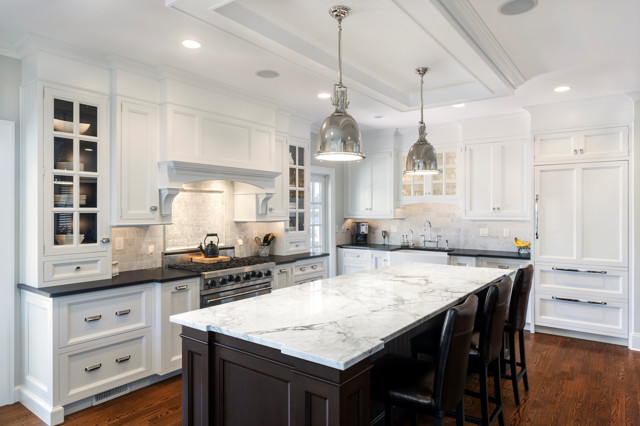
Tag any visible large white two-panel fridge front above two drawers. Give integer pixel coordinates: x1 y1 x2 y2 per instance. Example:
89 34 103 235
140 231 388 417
534 161 629 267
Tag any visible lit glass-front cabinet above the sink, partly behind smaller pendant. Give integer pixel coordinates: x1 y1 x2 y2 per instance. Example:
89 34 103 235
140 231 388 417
397 147 461 204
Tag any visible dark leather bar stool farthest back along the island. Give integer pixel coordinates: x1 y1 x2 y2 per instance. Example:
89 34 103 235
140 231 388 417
501 265 533 405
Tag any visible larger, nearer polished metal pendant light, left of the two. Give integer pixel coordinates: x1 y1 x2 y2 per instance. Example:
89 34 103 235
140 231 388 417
315 6 365 161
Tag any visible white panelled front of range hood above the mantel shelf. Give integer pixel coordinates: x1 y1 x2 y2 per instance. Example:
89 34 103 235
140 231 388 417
161 104 280 172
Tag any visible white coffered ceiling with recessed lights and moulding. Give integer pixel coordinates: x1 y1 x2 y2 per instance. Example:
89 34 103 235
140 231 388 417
0 0 640 130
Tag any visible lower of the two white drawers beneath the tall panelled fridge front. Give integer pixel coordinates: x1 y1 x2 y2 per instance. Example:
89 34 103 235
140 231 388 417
535 293 628 337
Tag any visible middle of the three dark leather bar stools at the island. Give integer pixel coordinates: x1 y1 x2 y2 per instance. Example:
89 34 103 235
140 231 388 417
465 277 511 426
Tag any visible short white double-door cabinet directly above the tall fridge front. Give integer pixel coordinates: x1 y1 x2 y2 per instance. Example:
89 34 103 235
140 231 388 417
534 126 629 163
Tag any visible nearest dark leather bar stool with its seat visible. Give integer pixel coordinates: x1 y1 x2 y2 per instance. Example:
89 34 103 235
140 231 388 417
371 296 478 426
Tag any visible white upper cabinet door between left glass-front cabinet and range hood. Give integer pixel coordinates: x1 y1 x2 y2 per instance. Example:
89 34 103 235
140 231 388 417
111 98 161 225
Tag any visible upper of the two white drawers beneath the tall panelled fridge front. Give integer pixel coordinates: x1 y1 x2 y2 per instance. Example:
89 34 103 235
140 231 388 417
535 264 629 301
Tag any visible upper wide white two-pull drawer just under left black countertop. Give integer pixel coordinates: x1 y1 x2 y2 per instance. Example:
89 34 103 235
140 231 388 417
58 285 152 348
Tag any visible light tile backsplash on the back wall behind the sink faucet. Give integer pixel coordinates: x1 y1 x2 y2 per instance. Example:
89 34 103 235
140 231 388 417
345 203 533 251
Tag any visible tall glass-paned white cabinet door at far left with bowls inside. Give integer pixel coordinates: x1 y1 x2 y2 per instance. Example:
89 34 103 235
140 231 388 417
43 88 110 255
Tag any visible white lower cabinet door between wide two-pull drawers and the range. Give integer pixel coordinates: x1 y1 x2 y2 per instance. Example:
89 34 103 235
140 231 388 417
154 278 200 375
